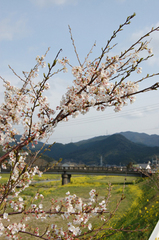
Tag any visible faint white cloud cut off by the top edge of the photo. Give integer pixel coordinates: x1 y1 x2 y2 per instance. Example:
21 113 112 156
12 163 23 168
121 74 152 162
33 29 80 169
30 0 77 7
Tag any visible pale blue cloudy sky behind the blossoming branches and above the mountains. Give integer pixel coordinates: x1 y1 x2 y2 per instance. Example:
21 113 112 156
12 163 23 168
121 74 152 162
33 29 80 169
0 0 159 143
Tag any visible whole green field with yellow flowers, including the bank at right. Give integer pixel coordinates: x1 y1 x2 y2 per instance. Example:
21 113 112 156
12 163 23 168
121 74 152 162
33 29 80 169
1 174 159 240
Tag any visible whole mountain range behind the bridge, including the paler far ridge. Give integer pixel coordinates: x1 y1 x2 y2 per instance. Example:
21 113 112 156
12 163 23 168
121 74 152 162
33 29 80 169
0 132 159 165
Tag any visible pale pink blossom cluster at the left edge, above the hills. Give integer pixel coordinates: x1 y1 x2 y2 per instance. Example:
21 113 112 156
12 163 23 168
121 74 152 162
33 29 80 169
0 53 55 151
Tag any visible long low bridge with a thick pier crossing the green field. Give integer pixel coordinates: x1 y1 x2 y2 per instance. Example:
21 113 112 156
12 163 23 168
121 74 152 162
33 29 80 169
44 166 149 185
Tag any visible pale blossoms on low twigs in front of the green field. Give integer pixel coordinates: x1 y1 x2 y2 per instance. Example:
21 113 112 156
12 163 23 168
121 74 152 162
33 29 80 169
0 189 106 240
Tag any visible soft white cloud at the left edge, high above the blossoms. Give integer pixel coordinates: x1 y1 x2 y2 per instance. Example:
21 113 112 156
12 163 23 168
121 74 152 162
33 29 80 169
0 17 28 41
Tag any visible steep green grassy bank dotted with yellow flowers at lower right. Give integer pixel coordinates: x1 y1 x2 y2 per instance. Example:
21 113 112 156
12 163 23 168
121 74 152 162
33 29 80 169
103 177 159 240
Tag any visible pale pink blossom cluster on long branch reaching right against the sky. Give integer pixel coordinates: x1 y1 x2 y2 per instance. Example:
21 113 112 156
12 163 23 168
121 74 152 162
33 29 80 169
57 45 150 117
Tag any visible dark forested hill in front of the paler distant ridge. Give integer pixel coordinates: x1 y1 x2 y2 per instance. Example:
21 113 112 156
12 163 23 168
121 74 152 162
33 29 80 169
41 134 159 165
